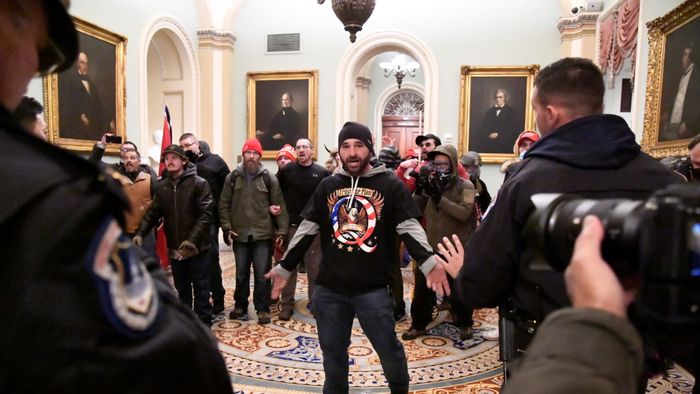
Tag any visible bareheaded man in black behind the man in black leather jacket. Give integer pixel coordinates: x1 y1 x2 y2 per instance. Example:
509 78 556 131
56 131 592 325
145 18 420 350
180 133 231 314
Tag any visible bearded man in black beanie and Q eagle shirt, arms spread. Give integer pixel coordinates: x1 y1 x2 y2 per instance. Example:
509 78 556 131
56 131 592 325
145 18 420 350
268 122 449 393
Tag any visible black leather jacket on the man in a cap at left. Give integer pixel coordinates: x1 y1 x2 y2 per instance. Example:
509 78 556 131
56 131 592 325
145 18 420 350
136 165 212 253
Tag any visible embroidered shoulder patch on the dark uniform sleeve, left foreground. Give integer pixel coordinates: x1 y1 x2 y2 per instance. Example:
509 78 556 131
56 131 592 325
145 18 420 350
85 217 159 338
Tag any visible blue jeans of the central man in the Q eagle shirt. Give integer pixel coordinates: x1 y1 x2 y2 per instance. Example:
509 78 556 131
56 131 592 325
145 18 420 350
313 285 409 393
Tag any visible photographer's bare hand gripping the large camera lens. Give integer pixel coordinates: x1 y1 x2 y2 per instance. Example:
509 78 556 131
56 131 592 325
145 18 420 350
564 216 632 318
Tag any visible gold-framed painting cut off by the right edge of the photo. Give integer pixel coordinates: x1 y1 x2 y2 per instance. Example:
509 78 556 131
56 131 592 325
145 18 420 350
642 0 700 158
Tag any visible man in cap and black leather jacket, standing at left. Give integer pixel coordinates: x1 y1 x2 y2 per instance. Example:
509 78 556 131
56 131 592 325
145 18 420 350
134 145 212 326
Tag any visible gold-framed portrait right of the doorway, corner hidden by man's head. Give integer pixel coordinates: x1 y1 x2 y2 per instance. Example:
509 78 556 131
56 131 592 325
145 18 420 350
459 65 540 163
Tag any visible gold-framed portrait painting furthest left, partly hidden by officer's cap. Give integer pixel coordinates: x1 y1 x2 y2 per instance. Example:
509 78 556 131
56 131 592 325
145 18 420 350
43 17 127 154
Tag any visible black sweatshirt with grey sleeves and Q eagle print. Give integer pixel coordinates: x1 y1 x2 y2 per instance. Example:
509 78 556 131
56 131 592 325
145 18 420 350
273 164 436 292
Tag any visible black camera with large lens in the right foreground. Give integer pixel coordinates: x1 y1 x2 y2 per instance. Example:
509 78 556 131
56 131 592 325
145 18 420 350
525 183 700 339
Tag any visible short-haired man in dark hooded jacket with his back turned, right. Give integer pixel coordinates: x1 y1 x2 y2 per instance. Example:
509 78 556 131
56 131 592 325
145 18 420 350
448 58 680 378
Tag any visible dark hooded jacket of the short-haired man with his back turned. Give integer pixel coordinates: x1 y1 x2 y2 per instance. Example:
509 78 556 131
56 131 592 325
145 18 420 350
456 115 681 321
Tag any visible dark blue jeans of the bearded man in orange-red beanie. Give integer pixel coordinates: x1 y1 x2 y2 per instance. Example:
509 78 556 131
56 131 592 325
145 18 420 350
233 239 272 312
